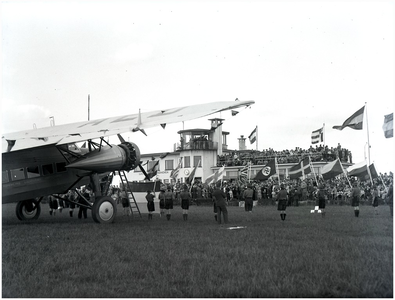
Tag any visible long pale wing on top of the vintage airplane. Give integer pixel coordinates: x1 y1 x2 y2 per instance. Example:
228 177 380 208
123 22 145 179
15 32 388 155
2 101 255 153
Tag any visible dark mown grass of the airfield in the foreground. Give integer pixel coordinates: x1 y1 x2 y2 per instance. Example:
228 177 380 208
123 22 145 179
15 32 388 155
2 205 393 298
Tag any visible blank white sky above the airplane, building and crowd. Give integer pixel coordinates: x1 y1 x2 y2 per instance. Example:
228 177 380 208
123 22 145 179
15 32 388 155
1 0 395 173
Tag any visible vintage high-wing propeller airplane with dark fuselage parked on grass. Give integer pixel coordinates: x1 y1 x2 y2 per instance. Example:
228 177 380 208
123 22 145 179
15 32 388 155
2 101 255 223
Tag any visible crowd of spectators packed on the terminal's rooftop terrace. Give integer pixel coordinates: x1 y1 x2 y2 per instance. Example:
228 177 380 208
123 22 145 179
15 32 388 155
217 143 352 167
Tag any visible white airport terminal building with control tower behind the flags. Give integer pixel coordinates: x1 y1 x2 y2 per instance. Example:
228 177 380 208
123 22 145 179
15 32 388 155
127 118 352 184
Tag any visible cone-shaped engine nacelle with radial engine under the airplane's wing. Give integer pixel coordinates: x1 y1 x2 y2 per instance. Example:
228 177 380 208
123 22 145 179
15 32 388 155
67 142 140 173
